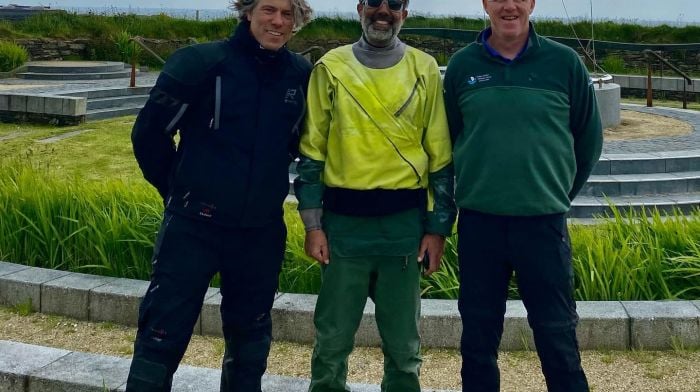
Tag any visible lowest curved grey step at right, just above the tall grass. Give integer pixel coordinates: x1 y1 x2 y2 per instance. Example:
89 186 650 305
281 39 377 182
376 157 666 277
569 192 700 218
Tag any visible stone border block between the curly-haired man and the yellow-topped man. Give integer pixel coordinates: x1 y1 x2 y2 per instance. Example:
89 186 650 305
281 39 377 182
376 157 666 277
272 293 316 343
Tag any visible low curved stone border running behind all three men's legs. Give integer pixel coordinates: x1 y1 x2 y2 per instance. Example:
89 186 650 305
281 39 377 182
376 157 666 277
0 262 700 350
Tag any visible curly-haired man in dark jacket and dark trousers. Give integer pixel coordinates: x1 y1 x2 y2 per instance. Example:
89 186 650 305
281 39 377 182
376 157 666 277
126 0 311 392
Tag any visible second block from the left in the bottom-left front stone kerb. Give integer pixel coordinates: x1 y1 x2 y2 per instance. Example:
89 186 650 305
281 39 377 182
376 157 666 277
27 352 131 392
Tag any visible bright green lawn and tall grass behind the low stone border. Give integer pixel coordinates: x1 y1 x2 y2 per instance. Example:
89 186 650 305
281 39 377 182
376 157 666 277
0 117 700 300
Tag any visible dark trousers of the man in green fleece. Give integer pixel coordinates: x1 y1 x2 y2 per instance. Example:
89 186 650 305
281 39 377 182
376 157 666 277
457 210 588 392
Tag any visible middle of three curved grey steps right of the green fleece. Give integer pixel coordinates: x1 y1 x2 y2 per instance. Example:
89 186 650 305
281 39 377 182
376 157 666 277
580 171 700 196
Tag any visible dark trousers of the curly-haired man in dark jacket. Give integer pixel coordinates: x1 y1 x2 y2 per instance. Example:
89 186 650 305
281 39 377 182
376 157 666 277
126 212 287 392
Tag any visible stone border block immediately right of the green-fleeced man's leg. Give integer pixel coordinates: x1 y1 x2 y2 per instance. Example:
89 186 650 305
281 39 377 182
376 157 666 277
576 301 630 350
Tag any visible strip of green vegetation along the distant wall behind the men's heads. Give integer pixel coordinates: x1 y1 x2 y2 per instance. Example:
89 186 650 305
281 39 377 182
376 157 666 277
0 12 700 43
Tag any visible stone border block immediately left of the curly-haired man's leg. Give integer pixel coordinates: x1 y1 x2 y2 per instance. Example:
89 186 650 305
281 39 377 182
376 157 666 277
89 279 149 326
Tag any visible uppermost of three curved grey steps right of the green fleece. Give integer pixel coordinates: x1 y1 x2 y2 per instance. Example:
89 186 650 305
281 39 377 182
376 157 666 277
592 150 700 175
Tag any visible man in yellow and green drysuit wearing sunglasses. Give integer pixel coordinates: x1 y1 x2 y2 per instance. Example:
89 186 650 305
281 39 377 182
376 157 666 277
295 0 456 392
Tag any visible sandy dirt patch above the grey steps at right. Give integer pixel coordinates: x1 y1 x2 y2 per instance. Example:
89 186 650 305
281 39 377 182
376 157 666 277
603 110 693 141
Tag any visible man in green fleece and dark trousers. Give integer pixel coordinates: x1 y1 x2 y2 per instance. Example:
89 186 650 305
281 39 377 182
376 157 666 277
445 0 602 392
